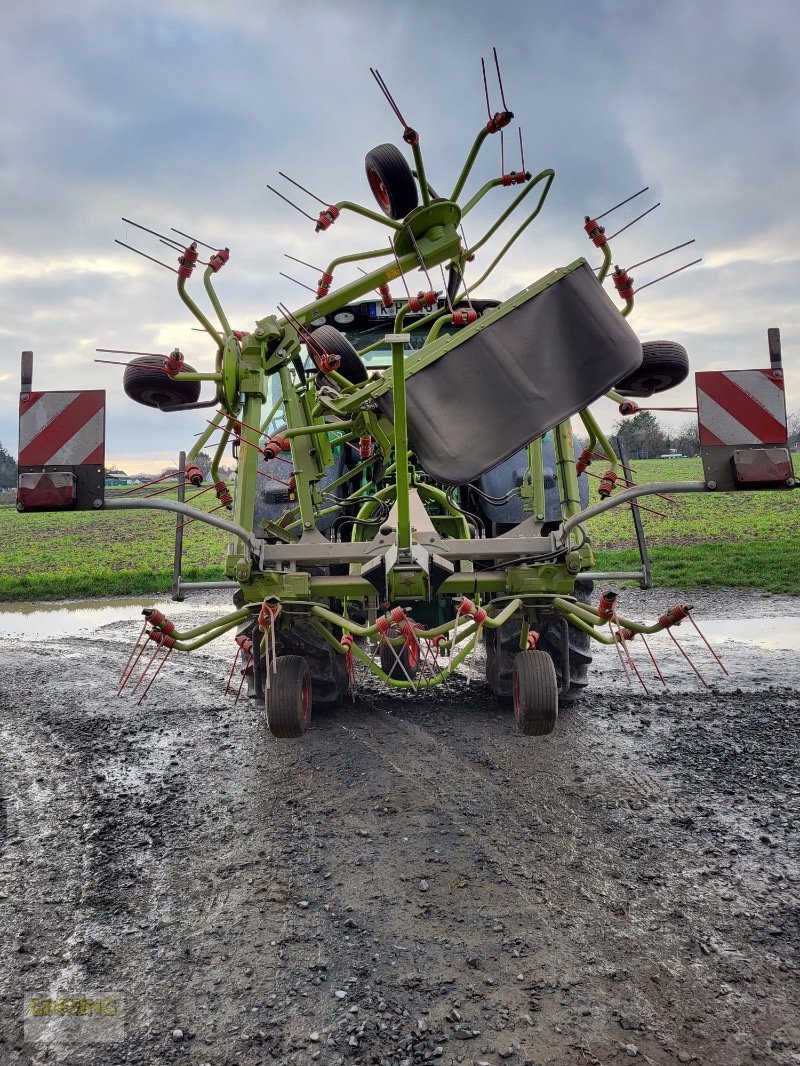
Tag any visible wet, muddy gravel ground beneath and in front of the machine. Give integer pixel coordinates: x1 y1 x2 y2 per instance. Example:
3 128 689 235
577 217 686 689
0 592 800 1066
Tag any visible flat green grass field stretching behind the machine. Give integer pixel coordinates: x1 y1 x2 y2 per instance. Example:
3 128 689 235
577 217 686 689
0 456 800 601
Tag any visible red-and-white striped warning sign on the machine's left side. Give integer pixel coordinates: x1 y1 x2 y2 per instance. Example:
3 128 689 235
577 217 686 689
18 389 106 467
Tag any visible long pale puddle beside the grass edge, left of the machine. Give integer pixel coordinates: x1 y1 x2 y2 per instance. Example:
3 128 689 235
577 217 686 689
0 596 231 641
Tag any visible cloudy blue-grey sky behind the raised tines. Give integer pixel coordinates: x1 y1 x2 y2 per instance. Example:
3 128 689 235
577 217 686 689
0 0 800 471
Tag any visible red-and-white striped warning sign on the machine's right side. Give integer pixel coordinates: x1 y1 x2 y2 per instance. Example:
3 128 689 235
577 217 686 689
694 370 787 446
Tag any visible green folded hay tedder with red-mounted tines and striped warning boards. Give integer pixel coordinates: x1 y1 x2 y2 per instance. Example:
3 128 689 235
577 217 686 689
18 55 795 737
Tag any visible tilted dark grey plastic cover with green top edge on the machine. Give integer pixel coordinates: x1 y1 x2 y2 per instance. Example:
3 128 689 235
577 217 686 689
375 259 642 485
